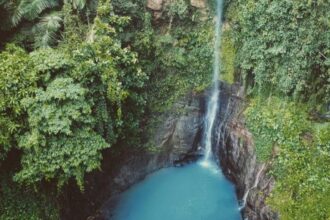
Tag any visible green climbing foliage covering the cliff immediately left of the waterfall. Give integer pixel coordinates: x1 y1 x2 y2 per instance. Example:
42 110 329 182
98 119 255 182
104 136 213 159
112 0 214 145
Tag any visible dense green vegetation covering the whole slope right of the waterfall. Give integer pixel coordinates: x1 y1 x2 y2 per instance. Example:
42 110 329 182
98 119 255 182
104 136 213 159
227 0 330 220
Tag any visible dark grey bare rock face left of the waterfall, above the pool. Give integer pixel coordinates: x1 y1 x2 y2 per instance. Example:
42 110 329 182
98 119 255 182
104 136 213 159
100 91 203 197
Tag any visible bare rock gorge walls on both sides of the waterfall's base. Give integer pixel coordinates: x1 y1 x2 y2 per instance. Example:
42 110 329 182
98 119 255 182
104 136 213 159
75 83 277 220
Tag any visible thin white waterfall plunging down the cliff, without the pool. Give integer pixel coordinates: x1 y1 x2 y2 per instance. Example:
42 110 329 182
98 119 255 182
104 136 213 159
203 0 223 165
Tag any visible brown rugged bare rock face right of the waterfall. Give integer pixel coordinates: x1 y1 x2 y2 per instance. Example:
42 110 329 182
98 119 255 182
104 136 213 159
214 83 278 220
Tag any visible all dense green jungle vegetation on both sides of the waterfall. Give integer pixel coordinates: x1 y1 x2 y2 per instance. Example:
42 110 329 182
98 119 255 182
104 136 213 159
0 0 330 220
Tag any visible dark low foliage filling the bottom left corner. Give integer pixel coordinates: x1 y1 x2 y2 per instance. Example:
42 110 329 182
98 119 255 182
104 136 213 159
0 175 60 220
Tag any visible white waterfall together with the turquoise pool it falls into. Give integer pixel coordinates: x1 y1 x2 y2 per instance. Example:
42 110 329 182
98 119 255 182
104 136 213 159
108 0 241 220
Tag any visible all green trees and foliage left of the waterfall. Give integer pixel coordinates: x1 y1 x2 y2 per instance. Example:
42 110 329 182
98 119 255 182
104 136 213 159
0 0 220 219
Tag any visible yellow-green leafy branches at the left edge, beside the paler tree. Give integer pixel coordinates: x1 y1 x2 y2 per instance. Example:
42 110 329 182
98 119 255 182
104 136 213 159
0 45 70 168
